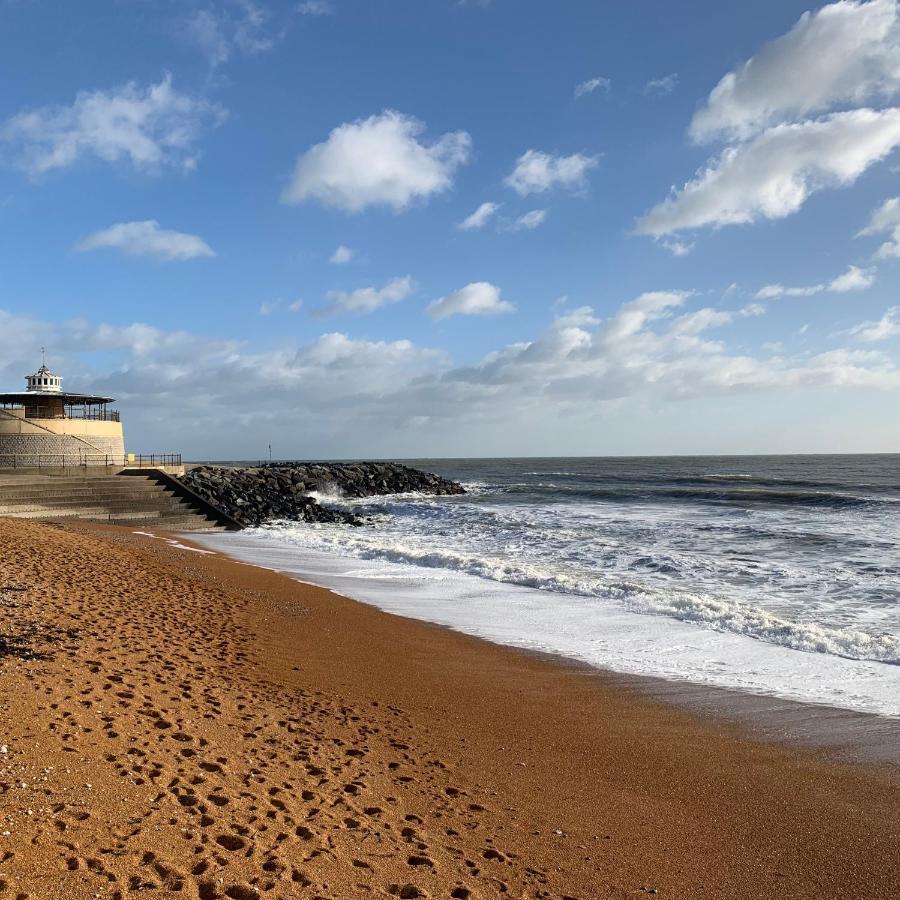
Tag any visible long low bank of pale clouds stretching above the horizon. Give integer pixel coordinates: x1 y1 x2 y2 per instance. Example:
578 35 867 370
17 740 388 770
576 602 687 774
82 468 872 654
0 291 900 456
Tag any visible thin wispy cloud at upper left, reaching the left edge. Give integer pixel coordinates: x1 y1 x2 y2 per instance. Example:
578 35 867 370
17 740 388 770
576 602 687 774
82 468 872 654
0 75 225 176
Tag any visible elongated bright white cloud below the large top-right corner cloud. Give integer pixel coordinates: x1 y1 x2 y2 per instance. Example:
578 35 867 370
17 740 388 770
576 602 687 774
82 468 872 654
637 109 900 237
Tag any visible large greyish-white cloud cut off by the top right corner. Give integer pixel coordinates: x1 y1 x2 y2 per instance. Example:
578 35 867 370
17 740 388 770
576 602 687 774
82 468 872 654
690 0 900 142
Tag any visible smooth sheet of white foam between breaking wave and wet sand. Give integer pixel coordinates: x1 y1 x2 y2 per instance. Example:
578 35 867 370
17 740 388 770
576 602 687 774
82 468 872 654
192 530 900 716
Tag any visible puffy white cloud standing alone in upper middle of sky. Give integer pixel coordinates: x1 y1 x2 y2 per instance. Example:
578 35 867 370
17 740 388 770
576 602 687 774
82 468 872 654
281 110 472 212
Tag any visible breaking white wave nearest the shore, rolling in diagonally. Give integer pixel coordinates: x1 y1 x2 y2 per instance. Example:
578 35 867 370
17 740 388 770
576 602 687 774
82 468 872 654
248 523 900 665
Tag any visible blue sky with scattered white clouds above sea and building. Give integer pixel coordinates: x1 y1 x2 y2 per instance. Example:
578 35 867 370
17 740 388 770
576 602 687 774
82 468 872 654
0 0 900 459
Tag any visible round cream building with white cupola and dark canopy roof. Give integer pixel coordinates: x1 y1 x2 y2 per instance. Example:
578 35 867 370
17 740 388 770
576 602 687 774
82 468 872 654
0 363 125 469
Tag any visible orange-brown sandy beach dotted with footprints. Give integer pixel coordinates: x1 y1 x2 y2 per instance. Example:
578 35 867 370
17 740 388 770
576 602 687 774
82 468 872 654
0 520 900 900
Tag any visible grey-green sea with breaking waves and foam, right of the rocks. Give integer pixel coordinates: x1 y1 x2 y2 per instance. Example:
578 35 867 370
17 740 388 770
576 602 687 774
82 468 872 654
195 455 900 717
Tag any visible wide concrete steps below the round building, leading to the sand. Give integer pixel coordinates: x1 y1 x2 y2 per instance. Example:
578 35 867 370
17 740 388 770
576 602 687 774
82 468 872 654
0 473 236 531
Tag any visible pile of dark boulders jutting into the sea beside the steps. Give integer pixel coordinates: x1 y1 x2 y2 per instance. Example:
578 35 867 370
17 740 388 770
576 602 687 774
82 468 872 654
179 462 465 527
